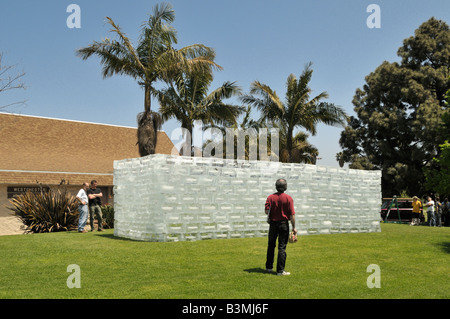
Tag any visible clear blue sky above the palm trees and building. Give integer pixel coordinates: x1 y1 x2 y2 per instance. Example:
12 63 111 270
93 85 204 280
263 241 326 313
0 0 450 166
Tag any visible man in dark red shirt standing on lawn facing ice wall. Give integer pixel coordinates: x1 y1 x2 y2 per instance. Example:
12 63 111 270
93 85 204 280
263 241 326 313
265 179 297 276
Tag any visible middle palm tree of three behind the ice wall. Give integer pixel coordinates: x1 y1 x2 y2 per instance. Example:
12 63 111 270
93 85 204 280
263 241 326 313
158 70 243 154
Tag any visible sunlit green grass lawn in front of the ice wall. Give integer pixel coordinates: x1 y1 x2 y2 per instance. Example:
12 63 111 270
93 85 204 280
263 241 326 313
0 224 450 299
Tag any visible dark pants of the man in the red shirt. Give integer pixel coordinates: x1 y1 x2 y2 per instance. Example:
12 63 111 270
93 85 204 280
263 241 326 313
266 221 289 272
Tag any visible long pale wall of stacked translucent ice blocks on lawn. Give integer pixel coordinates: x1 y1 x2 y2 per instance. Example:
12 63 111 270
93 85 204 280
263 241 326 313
114 154 381 241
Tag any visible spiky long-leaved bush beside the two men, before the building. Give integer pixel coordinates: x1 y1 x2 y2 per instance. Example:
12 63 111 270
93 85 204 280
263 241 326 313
8 190 79 233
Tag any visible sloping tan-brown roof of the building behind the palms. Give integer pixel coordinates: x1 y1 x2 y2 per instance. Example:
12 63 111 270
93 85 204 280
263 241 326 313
0 113 174 184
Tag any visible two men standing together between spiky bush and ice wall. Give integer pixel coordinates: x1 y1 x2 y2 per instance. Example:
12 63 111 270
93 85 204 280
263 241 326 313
76 180 103 233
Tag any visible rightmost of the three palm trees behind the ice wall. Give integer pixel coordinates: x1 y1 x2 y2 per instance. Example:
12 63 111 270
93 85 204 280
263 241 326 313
242 63 347 162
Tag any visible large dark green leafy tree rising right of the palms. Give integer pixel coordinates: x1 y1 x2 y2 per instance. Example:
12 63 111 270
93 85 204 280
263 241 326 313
340 18 450 196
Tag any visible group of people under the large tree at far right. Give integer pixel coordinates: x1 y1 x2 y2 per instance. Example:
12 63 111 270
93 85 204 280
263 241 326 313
410 196 450 227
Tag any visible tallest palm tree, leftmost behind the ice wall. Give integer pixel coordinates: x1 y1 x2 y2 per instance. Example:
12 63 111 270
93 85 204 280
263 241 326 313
77 3 221 156
